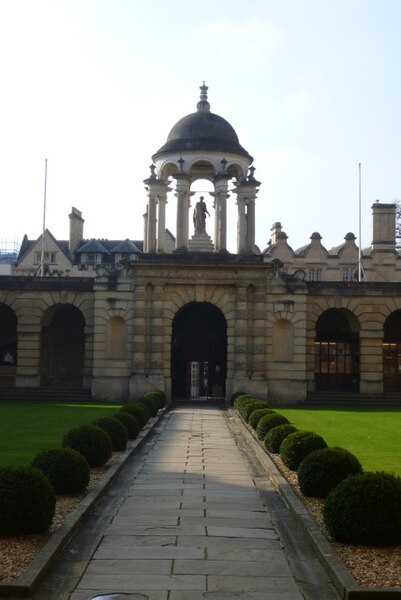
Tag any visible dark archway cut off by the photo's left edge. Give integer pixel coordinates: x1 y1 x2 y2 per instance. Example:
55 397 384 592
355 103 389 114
0 303 17 386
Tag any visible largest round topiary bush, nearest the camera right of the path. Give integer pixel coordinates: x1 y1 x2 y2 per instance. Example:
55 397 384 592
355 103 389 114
323 472 401 546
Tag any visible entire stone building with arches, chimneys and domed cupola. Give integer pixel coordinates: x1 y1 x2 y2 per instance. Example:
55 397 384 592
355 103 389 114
0 85 401 403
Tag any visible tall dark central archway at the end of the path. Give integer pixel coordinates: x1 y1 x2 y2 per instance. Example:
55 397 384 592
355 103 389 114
171 302 227 399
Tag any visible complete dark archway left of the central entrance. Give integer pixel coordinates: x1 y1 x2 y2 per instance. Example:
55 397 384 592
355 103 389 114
40 304 85 387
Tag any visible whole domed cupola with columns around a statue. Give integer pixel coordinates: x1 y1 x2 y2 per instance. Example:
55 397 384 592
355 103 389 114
144 82 260 254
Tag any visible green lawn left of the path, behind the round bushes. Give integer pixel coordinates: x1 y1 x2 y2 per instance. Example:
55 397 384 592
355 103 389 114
0 401 120 467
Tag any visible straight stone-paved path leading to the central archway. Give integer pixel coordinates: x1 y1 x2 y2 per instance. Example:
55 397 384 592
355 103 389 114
34 406 335 600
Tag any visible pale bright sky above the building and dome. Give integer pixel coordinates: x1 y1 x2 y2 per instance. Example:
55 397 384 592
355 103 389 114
0 0 401 251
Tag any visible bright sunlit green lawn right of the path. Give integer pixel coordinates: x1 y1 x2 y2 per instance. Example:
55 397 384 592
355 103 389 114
275 406 401 476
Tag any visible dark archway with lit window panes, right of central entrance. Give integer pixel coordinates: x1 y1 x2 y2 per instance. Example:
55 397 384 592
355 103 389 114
315 308 359 392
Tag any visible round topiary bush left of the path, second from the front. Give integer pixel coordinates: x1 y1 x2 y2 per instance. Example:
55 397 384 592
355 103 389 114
32 448 90 495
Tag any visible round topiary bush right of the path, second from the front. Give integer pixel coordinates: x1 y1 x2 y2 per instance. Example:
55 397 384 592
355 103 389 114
298 447 362 498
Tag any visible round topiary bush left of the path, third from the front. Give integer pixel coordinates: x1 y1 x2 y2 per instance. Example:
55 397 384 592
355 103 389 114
62 425 113 467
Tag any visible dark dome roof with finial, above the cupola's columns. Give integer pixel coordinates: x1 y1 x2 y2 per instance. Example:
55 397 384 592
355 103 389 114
153 83 253 162
